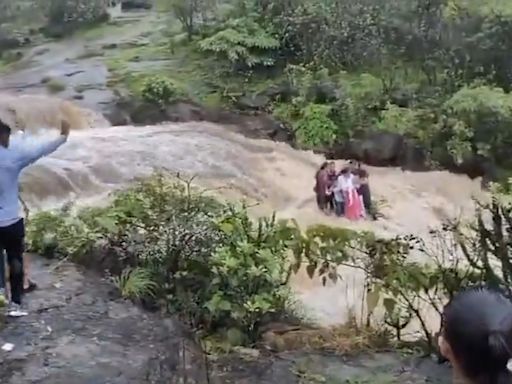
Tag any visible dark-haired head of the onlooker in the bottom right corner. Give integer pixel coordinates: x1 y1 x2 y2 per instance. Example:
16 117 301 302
439 288 512 384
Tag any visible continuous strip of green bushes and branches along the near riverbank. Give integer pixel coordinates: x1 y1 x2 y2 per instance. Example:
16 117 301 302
27 174 512 348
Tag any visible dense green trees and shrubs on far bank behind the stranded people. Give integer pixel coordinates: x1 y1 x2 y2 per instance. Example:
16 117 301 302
161 0 512 168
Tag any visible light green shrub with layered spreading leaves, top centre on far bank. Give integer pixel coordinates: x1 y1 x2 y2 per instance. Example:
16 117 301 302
199 18 280 69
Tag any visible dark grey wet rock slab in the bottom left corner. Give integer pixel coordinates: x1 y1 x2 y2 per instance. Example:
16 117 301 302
0 255 210 384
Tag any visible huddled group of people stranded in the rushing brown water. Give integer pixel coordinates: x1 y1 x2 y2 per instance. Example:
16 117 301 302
313 160 376 220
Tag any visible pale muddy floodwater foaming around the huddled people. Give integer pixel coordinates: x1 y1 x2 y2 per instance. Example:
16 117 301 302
17 122 481 326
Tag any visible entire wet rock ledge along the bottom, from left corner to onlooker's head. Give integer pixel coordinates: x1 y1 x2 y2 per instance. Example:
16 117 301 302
0 258 450 384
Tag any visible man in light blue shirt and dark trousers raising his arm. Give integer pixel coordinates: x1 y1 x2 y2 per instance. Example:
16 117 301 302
0 121 70 317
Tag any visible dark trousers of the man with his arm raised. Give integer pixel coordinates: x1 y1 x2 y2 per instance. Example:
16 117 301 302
0 219 25 304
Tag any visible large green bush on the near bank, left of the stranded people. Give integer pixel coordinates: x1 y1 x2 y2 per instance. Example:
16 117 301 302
27 174 289 343
